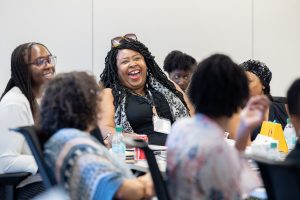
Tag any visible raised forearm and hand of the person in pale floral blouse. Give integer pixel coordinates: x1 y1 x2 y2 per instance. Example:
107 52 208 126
235 95 269 151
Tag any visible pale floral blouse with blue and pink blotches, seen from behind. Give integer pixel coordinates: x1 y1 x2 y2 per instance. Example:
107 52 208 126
167 114 261 200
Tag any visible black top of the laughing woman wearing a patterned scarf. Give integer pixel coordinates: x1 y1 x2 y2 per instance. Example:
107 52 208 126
126 91 173 145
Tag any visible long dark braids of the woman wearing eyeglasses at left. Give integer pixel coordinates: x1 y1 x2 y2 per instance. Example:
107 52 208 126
0 42 51 121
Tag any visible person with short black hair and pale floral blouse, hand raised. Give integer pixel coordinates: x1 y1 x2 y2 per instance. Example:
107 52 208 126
167 54 269 199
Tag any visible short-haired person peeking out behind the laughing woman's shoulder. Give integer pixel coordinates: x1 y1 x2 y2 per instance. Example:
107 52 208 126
163 50 197 91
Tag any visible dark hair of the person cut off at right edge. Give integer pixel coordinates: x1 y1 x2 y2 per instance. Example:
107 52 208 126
287 78 300 115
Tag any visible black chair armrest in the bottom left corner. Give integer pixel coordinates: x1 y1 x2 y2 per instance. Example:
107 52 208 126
0 172 30 200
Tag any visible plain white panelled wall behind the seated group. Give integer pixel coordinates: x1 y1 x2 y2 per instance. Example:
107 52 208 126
0 0 300 95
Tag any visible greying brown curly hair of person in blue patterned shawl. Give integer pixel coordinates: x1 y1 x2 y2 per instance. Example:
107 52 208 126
40 72 100 137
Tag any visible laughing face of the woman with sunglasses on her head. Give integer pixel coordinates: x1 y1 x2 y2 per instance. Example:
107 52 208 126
117 49 147 94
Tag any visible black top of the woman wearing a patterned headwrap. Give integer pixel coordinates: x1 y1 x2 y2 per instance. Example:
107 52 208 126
251 102 288 141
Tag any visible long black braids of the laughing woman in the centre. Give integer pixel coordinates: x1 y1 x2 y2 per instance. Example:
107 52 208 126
100 39 188 108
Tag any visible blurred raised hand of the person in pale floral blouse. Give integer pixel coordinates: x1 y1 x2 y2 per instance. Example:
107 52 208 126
240 95 270 131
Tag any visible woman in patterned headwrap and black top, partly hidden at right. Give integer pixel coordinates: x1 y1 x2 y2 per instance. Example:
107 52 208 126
228 60 288 142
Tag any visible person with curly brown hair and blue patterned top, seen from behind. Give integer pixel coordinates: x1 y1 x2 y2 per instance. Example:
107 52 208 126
40 72 153 199
